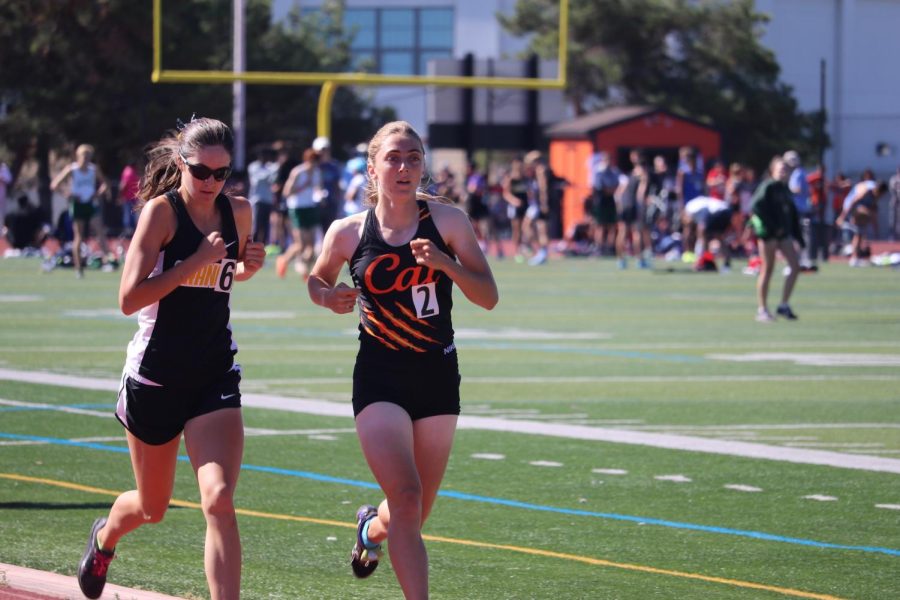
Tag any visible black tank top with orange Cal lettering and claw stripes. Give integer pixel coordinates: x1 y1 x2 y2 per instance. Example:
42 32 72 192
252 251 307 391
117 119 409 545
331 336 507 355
350 200 456 356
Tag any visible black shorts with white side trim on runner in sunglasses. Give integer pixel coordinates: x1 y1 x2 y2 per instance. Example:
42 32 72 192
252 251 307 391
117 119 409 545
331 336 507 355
116 365 241 446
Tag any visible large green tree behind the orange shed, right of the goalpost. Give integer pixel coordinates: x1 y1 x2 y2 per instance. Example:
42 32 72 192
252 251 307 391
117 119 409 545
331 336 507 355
499 0 827 168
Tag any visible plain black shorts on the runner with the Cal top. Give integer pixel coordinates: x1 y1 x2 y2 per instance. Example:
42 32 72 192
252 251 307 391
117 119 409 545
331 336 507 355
353 344 461 421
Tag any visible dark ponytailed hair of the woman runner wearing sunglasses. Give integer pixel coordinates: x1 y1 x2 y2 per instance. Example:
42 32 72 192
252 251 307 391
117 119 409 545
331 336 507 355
136 118 234 208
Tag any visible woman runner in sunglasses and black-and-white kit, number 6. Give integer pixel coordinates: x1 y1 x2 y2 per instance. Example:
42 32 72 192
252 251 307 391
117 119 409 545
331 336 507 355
78 119 265 600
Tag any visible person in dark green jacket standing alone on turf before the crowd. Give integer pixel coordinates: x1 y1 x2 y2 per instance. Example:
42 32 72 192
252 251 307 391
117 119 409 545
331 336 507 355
750 156 803 323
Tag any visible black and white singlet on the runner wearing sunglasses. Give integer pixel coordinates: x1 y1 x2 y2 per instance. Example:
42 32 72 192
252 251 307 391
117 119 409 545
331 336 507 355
125 191 239 388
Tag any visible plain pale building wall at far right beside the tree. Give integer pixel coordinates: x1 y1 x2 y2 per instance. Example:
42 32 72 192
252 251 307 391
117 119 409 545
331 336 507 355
756 0 900 179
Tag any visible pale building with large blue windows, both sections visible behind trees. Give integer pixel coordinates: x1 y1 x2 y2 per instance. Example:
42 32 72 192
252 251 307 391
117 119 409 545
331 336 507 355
273 0 900 178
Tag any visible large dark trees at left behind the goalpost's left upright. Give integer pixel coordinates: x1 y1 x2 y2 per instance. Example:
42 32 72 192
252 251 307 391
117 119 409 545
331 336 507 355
0 0 389 216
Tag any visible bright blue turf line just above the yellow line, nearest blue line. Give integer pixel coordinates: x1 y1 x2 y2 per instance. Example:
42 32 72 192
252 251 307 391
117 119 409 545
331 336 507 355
0 432 900 556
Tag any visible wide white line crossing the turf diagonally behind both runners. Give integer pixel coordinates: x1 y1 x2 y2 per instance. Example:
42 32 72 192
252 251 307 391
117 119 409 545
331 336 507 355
0 369 900 474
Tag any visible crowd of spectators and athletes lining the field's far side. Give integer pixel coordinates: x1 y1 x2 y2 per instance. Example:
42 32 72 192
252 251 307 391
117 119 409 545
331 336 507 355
0 137 900 274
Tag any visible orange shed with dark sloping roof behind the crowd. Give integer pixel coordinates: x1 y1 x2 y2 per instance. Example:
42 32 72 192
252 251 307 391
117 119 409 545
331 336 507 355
546 106 721 233
